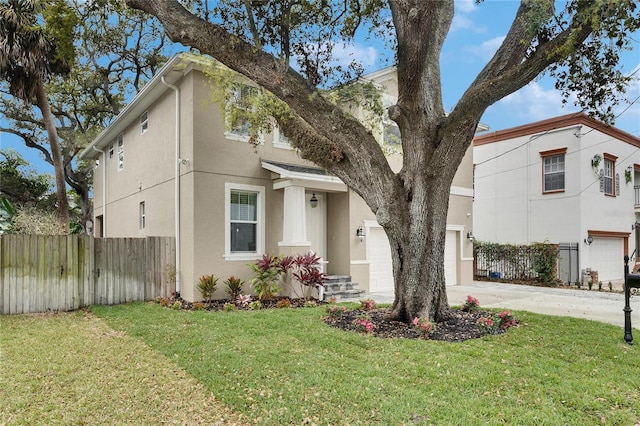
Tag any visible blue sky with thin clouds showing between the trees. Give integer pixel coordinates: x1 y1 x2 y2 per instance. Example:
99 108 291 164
0 0 640 173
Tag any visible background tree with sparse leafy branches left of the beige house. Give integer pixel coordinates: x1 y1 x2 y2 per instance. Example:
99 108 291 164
0 0 169 228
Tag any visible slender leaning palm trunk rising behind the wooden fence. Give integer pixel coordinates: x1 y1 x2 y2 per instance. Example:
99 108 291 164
36 80 69 233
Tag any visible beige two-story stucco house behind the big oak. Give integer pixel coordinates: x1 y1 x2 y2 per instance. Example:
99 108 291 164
82 54 473 301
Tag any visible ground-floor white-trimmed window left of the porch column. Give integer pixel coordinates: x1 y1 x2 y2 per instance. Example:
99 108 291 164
225 183 265 260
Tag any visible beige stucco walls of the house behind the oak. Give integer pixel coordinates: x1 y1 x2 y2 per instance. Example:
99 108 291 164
87 60 472 300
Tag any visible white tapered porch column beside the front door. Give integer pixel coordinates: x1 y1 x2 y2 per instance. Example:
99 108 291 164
278 186 311 246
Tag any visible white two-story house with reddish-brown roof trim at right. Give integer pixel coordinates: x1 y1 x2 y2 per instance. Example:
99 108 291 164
473 113 640 284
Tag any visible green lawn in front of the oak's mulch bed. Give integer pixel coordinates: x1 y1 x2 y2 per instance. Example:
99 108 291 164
84 304 640 425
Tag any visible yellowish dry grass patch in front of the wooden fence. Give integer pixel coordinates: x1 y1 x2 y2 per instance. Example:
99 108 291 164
0 312 248 425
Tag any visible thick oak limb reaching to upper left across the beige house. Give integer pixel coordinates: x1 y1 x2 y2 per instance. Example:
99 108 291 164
126 0 396 211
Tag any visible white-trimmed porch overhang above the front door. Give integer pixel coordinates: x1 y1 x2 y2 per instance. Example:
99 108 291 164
262 160 347 192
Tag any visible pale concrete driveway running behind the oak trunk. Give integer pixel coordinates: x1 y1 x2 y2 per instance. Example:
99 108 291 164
358 281 640 332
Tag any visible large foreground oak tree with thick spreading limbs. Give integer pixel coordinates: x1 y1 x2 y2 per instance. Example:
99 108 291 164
126 0 639 321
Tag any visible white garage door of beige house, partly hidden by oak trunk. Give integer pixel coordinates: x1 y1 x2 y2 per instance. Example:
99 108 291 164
367 227 457 291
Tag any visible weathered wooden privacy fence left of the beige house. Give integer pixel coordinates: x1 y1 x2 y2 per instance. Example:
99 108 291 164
0 235 175 314
